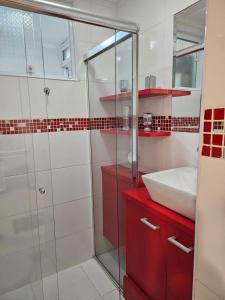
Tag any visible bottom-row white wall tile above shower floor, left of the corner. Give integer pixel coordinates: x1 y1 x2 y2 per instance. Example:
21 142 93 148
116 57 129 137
56 229 94 270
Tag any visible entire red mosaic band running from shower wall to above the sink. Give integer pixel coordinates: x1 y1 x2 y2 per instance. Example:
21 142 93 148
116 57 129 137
0 116 200 135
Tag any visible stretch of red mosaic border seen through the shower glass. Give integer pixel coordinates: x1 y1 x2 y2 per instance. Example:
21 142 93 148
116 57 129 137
0 118 122 135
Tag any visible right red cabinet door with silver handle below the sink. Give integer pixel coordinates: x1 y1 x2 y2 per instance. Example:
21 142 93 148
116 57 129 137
162 223 194 300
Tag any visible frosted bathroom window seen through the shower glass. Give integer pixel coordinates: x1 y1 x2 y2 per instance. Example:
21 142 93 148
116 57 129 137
0 7 75 80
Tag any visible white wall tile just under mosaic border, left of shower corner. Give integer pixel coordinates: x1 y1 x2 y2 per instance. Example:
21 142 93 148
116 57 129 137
50 131 90 169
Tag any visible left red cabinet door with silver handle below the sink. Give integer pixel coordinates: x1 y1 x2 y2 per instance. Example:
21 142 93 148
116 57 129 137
126 200 166 300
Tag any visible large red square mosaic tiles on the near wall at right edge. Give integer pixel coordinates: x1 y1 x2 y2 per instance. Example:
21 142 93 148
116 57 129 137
202 108 225 158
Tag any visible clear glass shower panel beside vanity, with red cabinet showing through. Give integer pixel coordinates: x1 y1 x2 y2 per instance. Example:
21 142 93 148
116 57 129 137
87 30 137 287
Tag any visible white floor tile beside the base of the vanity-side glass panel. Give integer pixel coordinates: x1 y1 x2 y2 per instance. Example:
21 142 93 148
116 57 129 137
81 259 116 296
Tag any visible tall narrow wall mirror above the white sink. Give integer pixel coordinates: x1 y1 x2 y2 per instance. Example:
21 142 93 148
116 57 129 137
172 0 206 132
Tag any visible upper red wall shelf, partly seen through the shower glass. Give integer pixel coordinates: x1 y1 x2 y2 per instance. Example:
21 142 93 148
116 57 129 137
100 89 191 101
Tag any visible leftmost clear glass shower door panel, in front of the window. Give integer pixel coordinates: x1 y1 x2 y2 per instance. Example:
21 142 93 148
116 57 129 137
0 6 58 300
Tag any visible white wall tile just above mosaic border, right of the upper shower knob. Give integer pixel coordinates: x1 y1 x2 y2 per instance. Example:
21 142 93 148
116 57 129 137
46 80 88 118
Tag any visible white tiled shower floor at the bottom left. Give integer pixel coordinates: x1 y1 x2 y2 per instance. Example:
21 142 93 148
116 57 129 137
0 258 124 300
